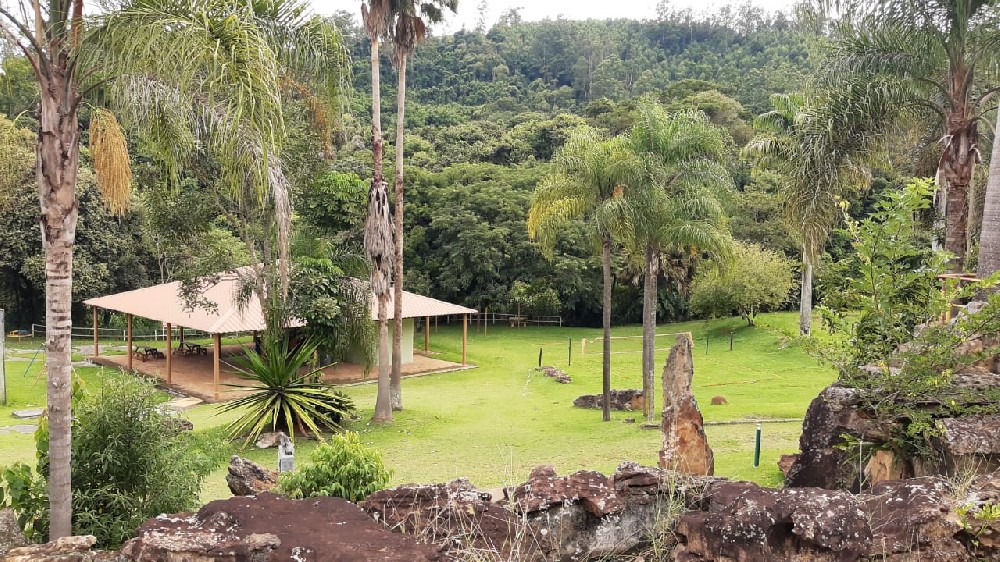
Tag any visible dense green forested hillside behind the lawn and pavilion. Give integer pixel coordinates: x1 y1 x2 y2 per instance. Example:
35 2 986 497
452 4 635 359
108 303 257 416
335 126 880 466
0 7 815 326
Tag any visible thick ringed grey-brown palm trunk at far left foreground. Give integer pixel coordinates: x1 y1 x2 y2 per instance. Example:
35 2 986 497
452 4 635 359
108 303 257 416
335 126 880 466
36 65 80 540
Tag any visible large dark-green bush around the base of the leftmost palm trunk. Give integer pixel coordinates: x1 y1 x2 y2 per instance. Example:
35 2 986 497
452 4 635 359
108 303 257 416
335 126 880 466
0 371 229 548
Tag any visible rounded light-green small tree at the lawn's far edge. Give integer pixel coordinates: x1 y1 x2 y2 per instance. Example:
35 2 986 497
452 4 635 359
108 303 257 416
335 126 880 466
691 242 794 326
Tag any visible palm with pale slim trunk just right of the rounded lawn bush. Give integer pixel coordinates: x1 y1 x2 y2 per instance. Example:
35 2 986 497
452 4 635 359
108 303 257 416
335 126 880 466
743 85 903 335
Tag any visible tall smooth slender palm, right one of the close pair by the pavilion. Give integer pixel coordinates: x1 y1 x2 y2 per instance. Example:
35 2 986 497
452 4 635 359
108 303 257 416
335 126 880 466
389 0 458 410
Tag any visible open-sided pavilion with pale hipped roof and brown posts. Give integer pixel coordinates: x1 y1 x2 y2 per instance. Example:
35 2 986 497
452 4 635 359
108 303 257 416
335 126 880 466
84 272 477 400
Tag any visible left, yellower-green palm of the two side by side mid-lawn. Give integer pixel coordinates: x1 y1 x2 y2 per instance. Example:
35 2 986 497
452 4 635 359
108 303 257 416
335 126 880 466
528 129 639 421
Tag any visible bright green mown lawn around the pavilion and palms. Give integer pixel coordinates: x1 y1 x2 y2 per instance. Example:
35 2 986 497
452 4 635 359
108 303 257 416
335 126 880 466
0 313 834 499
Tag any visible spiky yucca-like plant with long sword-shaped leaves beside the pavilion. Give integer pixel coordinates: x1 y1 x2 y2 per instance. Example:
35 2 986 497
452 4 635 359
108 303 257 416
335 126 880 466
220 337 354 441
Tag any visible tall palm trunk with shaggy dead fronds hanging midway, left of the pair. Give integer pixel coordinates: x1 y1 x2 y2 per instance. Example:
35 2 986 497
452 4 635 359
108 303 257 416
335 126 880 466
361 0 395 422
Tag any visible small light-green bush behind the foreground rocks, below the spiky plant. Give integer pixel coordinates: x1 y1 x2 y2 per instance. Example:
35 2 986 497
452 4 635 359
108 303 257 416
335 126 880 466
278 432 391 502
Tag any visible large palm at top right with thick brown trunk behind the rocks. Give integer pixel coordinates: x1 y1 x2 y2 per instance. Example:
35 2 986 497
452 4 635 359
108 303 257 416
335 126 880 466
832 0 1000 271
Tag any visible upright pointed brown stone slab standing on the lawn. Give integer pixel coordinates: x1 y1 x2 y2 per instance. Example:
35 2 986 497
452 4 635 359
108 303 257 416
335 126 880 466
660 334 715 476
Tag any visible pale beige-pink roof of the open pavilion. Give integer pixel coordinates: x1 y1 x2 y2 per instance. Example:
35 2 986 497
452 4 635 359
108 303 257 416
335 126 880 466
84 273 476 334
